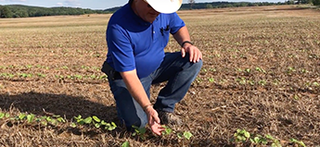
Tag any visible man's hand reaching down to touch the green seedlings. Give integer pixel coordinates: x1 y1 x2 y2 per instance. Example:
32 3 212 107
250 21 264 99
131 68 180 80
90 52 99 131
145 107 165 135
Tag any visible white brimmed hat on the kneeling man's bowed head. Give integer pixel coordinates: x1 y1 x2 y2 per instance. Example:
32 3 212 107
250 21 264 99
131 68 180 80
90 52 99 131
145 0 182 13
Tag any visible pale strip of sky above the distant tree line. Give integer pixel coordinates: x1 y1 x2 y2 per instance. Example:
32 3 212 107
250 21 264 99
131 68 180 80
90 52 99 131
0 0 284 10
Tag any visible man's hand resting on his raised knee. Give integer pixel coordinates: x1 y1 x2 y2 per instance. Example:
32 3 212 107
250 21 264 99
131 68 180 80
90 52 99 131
181 43 202 63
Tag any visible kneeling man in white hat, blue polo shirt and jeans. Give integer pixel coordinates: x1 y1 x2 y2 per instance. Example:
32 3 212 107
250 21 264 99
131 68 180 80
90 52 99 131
102 0 202 135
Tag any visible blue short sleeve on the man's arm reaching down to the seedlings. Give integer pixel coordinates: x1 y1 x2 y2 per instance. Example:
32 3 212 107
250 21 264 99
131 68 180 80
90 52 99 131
106 25 135 72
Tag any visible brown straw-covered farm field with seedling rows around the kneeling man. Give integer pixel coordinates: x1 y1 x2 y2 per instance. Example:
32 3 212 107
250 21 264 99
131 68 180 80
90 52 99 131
0 6 320 147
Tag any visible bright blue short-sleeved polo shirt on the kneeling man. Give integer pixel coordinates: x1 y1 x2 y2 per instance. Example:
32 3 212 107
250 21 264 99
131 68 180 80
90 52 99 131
106 4 185 78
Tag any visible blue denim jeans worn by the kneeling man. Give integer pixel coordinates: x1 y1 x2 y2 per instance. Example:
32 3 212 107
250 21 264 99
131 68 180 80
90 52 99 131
109 52 202 130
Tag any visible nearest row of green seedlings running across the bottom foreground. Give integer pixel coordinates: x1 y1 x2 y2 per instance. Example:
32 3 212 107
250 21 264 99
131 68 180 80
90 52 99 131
0 112 306 147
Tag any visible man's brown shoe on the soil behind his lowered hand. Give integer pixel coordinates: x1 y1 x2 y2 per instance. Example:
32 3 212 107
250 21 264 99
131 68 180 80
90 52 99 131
158 111 182 126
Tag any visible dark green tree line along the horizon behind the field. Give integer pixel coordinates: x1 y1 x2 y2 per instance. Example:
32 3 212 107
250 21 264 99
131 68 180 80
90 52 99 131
0 0 320 18
